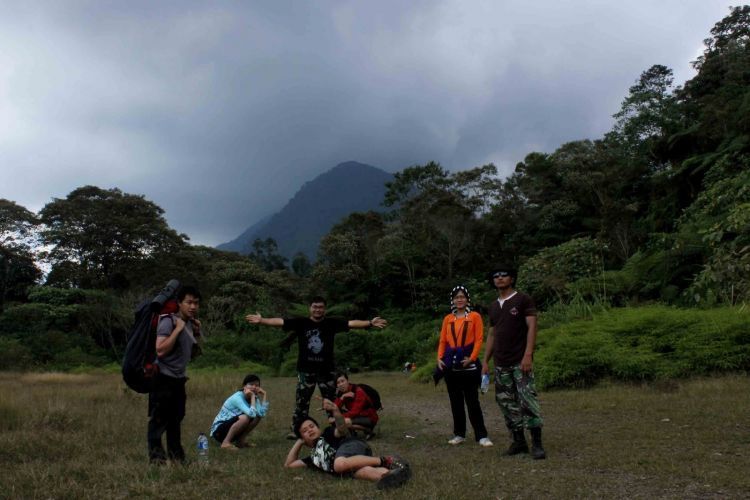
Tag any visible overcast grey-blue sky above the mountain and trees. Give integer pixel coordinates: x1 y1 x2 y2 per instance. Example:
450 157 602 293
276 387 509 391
0 0 731 245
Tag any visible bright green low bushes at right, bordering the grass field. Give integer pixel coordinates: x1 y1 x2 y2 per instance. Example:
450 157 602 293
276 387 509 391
535 306 750 387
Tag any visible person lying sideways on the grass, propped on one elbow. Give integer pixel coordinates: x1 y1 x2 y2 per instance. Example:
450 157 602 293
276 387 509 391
284 399 411 489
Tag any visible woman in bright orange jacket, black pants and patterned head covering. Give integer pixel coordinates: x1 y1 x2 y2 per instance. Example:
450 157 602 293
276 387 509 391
438 285 492 447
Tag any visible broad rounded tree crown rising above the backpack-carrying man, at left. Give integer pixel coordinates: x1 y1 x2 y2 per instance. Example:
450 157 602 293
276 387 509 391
40 186 187 287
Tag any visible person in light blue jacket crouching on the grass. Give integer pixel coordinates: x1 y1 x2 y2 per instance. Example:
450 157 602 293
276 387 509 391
211 374 268 450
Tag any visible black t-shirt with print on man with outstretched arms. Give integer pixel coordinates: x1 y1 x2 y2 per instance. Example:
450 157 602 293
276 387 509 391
284 318 349 373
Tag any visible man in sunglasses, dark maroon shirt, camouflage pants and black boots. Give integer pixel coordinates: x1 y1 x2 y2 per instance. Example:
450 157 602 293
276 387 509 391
482 265 546 459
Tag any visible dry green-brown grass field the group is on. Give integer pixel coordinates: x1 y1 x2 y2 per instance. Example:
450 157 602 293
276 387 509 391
0 372 750 499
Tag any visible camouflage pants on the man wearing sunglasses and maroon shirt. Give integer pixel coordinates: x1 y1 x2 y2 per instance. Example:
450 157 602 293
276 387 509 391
495 364 543 431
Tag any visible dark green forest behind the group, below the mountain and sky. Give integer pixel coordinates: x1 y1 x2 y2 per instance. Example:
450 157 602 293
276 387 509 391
0 6 750 385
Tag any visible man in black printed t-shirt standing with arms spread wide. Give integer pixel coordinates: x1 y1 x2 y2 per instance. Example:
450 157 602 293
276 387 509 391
245 296 388 439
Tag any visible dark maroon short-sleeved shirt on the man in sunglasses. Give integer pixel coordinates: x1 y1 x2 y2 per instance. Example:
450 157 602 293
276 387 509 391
489 292 536 366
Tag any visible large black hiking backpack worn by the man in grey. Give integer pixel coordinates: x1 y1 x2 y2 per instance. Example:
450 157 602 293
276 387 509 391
122 280 180 394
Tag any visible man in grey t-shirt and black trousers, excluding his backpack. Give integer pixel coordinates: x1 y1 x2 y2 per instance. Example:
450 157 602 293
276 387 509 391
147 286 201 465
